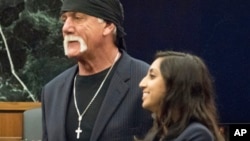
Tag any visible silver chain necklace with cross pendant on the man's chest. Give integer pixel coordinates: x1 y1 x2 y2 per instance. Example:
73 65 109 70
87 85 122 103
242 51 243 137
73 52 119 139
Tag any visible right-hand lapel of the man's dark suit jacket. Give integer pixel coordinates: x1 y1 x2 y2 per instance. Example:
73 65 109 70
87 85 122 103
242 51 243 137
90 53 130 141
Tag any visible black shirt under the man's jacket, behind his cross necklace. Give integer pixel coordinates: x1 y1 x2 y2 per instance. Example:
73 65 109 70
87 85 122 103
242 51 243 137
66 66 115 141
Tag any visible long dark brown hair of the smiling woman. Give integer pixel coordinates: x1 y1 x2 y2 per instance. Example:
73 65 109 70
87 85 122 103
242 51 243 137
140 51 224 141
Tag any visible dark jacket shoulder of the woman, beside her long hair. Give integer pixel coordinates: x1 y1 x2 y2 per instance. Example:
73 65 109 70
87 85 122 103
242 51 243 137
174 122 214 141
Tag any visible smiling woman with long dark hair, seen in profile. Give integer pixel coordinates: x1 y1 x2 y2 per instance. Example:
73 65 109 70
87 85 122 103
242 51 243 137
139 51 224 141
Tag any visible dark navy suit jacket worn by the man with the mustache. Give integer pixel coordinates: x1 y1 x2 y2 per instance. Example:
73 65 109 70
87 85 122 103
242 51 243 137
42 51 152 141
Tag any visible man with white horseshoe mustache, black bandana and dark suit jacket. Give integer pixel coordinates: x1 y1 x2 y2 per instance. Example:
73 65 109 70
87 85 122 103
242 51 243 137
42 0 152 141
